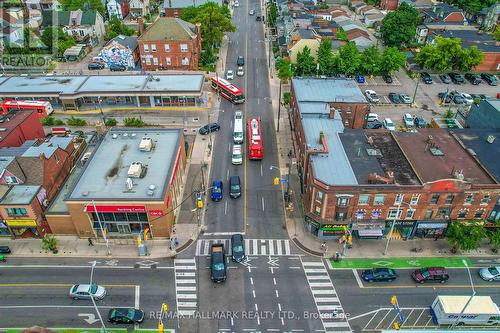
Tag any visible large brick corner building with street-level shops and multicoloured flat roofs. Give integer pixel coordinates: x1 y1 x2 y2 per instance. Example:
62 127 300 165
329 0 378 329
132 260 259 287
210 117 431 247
291 92 500 239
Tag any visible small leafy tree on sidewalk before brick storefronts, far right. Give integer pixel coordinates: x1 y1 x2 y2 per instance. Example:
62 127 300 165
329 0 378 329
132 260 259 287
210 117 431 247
446 221 486 252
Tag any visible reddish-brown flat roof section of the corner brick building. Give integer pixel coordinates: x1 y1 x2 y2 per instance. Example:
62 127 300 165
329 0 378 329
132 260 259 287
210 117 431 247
393 128 495 184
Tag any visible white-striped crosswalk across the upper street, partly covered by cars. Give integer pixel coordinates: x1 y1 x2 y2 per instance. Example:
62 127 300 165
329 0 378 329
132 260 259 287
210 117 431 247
196 239 292 256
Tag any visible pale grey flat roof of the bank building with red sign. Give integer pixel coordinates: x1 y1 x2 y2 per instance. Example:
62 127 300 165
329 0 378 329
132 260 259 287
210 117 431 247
67 128 182 201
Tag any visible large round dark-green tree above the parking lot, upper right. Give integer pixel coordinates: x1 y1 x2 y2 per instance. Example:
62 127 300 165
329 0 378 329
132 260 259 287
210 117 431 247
380 3 420 49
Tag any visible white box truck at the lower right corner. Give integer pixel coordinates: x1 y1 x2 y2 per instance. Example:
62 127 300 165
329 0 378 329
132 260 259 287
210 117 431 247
430 296 500 325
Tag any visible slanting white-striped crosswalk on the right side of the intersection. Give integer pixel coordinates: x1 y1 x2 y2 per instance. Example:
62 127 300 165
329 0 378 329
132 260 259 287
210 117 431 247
301 258 352 333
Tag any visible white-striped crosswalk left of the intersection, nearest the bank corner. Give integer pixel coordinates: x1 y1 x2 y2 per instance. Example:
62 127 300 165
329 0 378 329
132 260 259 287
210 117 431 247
174 258 198 316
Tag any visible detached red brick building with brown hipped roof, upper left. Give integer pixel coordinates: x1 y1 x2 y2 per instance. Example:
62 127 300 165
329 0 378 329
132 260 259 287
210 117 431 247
138 17 201 70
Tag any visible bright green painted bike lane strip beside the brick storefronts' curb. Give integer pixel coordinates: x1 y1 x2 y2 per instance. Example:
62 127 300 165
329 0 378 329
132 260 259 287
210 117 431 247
330 257 472 269
